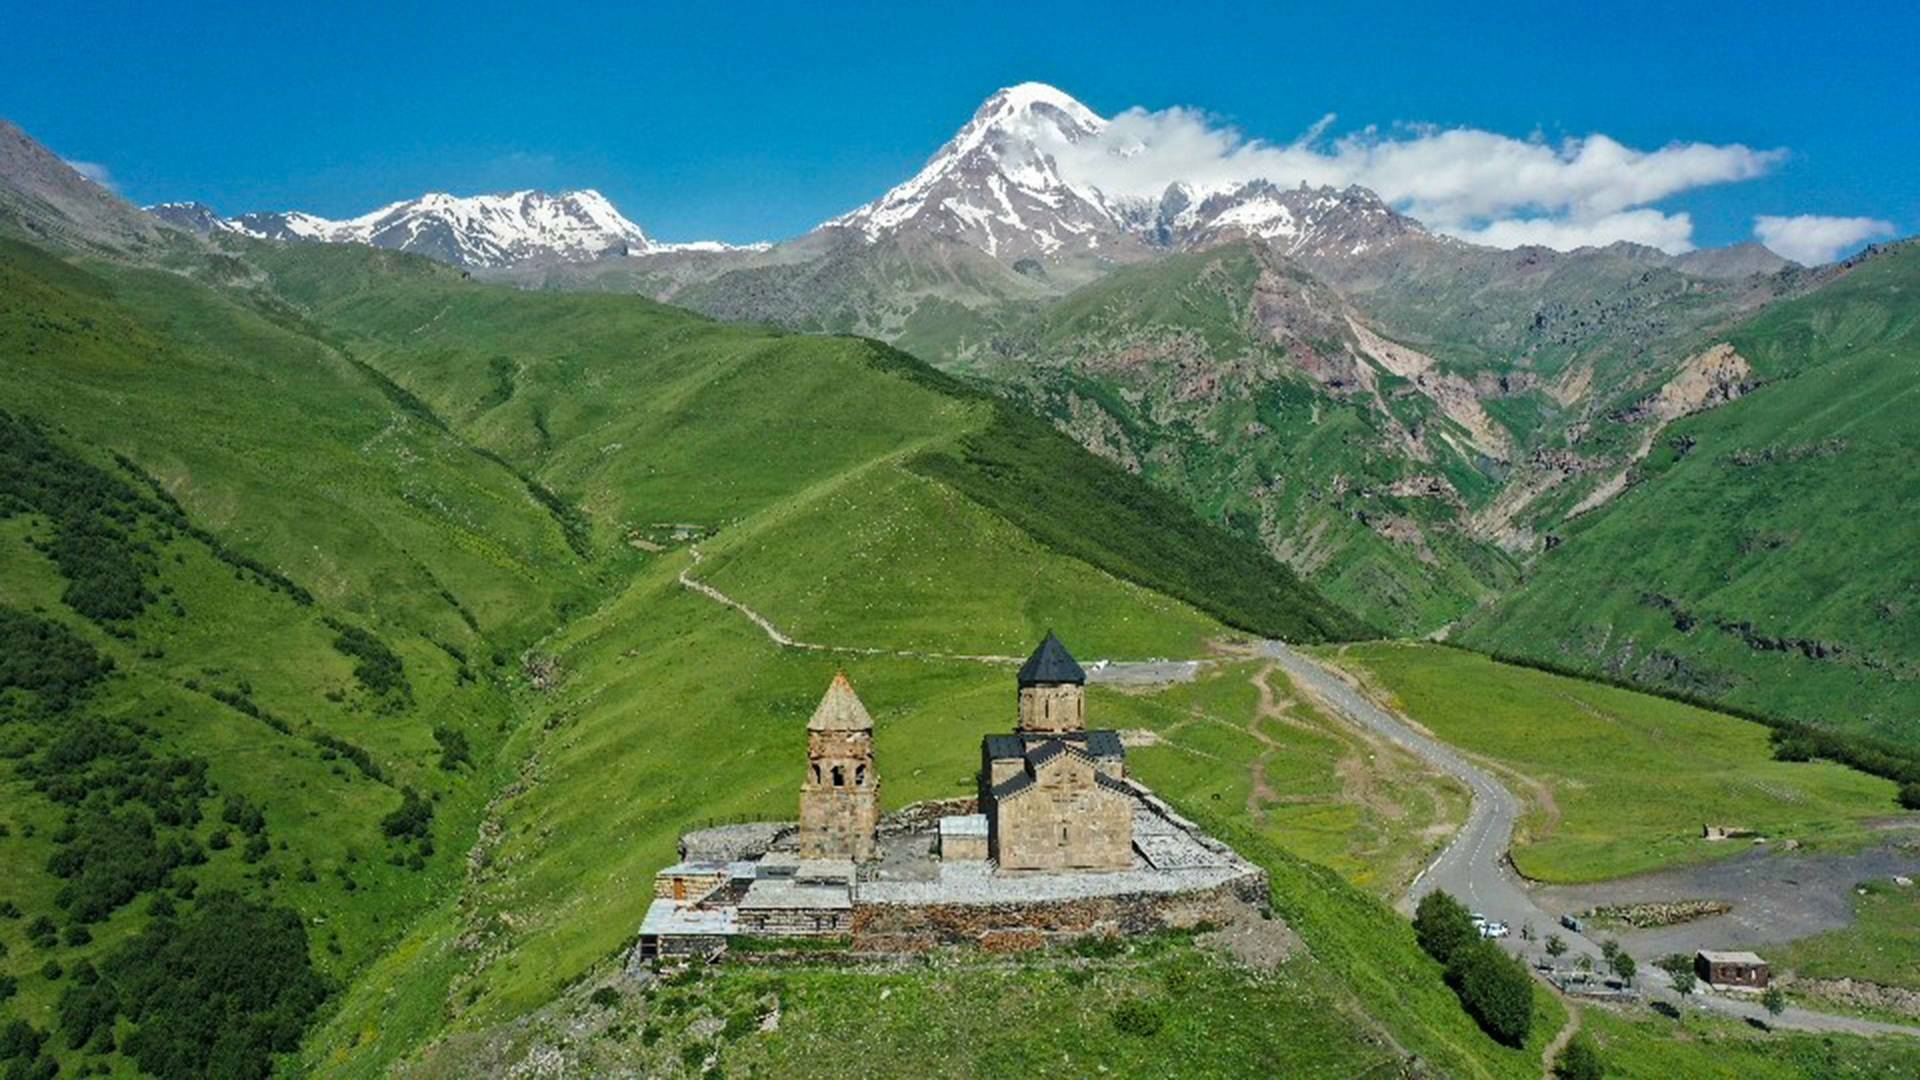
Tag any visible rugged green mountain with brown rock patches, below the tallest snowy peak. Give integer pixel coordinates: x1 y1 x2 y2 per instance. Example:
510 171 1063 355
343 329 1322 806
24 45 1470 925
989 244 1511 630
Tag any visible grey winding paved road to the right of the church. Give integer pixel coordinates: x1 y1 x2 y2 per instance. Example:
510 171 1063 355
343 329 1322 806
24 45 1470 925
1265 642 1920 1036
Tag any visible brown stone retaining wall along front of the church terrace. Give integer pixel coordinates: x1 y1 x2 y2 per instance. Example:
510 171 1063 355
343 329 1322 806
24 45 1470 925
851 871 1267 953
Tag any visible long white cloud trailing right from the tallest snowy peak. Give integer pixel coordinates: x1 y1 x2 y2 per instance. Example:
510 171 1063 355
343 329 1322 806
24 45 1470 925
1048 108 1786 252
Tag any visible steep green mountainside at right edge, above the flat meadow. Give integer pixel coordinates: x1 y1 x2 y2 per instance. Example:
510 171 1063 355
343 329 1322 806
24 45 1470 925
1461 246 1920 748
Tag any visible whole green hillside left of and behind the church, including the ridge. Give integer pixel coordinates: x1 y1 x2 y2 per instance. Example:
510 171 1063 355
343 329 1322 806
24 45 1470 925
0 228 1357 1074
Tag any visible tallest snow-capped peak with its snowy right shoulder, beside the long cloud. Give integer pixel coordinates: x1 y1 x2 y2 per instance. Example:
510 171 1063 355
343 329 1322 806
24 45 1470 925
822 83 1427 261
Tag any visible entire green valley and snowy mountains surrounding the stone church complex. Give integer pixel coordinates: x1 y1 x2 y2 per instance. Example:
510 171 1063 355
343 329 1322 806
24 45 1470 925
0 69 1920 1080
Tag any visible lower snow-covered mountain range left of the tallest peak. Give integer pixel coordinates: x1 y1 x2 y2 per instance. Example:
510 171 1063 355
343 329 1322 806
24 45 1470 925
146 190 760 269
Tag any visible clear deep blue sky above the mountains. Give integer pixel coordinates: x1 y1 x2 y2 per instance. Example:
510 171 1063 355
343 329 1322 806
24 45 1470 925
0 0 1920 255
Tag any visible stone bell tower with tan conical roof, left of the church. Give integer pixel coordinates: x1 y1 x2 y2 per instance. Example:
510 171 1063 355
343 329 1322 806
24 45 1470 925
801 673 879 863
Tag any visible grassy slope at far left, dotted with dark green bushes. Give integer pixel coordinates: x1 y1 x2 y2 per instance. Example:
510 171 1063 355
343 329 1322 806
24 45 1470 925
0 244 582 1063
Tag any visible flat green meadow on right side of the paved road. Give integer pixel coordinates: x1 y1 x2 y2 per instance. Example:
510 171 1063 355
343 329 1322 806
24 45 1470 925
1336 644 1897 882
